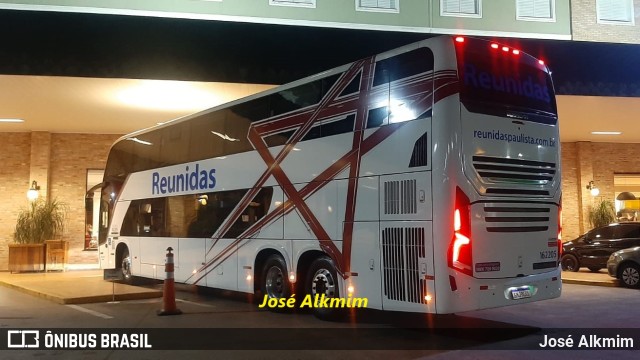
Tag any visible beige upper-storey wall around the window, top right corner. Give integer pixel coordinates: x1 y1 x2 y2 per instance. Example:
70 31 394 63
571 0 640 44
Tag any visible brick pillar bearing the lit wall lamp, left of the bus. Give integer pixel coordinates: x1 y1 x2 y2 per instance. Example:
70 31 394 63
29 131 51 200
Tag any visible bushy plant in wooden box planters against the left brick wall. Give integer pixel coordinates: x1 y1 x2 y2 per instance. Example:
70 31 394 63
9 199 67 272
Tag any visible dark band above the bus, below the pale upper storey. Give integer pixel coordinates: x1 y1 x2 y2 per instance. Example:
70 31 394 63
0 10 640 96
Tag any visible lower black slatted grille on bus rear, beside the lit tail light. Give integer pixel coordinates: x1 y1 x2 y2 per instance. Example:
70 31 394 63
483 204 551 233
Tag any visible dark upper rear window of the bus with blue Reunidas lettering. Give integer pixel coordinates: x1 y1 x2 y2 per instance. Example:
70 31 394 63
457 41 557 124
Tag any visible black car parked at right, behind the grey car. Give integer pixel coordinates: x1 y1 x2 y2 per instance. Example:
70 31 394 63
561 222 640 272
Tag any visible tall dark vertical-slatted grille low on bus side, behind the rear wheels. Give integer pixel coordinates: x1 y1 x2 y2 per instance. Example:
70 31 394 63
382 227 427 304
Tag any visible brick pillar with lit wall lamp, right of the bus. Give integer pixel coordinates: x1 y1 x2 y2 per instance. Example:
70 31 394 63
576 141 597 234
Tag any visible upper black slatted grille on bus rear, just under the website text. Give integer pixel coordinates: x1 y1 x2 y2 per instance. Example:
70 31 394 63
473 156 556 185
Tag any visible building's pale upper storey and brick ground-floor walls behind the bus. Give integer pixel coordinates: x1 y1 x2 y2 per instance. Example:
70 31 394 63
0 0 640 271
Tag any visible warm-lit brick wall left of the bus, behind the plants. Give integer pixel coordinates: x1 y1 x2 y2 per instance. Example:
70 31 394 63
0 133 120 271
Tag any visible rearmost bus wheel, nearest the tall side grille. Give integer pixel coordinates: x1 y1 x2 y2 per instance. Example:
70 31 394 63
307 256 342 319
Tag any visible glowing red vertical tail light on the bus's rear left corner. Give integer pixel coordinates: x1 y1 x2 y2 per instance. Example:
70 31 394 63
447 187 473 275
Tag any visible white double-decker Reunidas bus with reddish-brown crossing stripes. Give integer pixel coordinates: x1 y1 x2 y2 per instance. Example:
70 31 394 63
99 36 562 315
